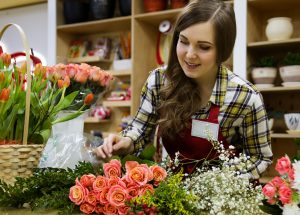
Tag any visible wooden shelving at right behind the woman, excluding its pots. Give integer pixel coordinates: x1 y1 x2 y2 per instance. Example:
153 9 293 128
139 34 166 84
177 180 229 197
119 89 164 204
245 0 300 179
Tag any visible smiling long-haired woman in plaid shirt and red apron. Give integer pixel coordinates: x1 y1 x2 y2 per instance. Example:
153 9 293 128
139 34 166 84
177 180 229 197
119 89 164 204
97 0 272 179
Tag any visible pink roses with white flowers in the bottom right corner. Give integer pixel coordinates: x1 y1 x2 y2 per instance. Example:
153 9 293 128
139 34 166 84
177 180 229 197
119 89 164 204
262 155 300 215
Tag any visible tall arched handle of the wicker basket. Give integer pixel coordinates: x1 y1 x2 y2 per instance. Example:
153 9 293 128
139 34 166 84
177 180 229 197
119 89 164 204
0 23 31 145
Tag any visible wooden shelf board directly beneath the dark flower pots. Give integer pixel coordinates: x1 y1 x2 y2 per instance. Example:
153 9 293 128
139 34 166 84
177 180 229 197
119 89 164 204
57 16 131 34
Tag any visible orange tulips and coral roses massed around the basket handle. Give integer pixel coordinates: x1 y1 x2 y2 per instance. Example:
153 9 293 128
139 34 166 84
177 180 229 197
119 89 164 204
0 53 112 144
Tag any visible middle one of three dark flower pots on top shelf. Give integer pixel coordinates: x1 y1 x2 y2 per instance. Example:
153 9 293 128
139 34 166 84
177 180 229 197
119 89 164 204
90 0 116 20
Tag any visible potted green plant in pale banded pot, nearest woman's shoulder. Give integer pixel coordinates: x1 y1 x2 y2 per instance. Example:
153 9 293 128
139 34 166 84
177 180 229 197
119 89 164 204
251 56 277 86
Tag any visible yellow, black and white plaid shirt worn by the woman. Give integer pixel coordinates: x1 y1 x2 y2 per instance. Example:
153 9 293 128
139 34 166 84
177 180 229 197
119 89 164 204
122 66 273 178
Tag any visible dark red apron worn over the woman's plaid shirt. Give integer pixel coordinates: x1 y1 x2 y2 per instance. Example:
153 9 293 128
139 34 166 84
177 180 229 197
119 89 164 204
158 104 229 173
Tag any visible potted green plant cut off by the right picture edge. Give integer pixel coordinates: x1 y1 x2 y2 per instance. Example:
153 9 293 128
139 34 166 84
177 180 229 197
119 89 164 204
279 52 300 86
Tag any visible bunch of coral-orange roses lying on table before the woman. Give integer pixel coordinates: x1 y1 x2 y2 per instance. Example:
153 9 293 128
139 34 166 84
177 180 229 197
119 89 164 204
69 159 167 214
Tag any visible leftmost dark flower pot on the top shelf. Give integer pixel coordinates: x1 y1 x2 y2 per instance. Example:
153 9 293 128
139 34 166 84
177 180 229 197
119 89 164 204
63 0 89 24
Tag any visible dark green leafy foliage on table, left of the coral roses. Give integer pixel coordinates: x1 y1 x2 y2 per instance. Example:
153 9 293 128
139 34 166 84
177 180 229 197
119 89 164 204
0 162 97 214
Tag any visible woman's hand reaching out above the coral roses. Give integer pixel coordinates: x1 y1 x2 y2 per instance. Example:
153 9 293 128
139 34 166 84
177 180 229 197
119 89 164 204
95 134 134 159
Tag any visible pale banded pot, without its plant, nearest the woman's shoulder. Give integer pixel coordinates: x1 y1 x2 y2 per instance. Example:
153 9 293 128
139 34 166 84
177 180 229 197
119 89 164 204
252 67 277 84
